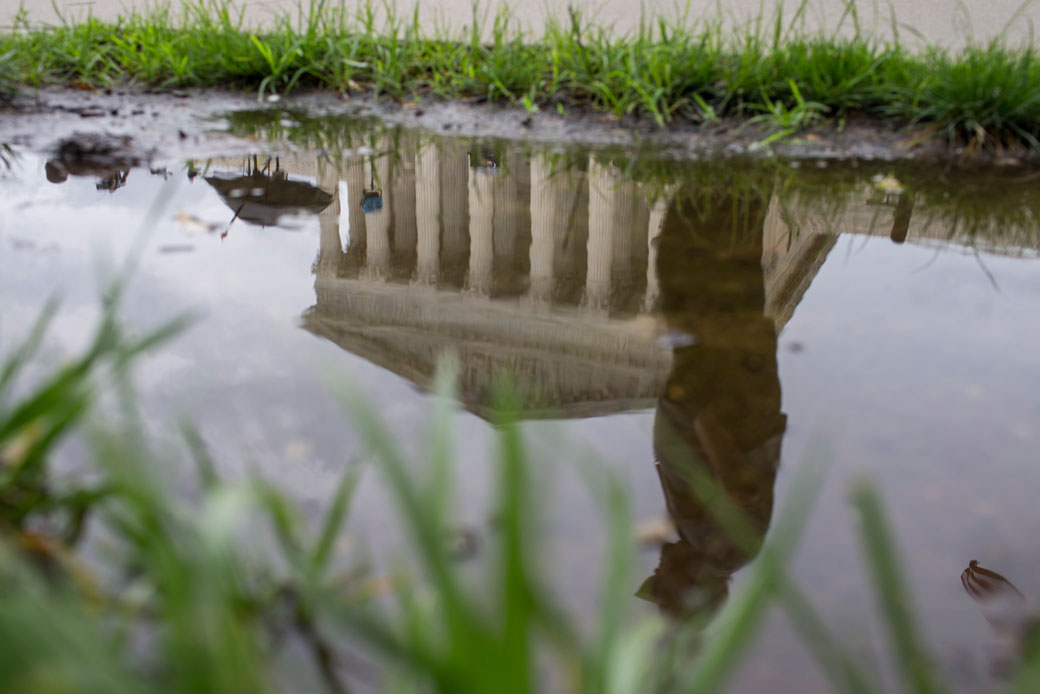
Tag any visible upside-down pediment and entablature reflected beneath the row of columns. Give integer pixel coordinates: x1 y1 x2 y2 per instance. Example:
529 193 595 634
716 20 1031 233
303 278 672 417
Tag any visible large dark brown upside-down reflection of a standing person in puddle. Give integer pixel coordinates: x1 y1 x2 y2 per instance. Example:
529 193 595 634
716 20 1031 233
641 189 786 618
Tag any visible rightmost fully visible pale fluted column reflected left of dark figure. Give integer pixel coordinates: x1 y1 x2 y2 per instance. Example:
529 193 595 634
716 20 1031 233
584 159 621 311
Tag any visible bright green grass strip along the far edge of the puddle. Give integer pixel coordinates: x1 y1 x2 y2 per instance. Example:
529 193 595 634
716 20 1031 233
0 0 1040 150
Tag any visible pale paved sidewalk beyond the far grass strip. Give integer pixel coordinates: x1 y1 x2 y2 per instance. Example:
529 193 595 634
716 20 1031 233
0 0 1040 47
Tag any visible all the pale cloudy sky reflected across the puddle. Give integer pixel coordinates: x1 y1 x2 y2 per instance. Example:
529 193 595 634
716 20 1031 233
0 156 1040 691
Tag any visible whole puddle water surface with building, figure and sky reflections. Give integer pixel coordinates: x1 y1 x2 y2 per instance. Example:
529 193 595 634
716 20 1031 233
0 113 1040 692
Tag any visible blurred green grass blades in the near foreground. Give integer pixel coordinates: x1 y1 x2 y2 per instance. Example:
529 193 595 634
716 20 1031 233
6 252 1040 694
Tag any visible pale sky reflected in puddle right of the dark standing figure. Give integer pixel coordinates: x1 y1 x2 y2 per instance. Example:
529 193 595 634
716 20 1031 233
739 237 1040 691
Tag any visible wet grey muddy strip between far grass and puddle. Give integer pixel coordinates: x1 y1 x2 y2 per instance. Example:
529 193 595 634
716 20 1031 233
0 88 1040 168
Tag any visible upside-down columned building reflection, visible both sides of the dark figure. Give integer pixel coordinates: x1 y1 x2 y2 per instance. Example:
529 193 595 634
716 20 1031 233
213 140 833 416
